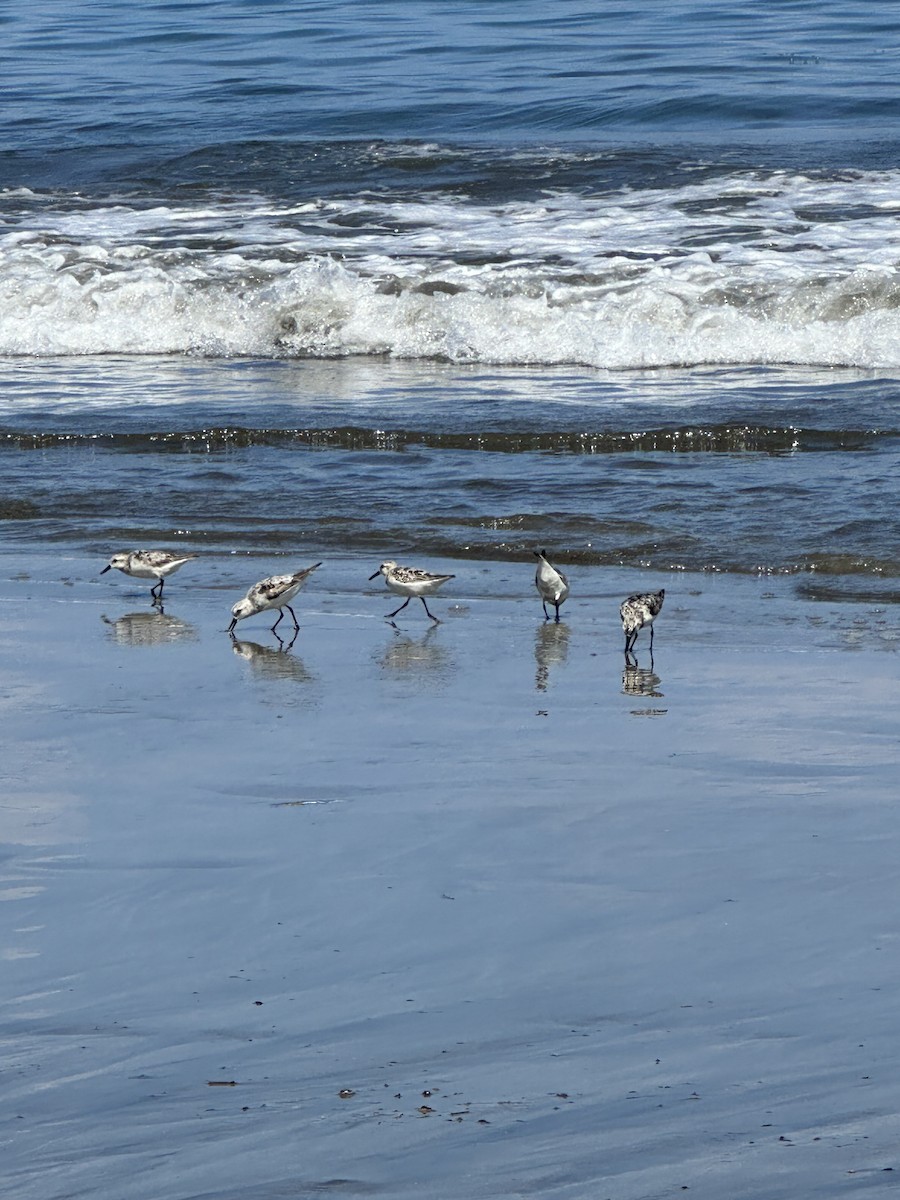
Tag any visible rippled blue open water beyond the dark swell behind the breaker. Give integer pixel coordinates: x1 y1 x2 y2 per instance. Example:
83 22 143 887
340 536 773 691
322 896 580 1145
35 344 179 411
7 0 900 164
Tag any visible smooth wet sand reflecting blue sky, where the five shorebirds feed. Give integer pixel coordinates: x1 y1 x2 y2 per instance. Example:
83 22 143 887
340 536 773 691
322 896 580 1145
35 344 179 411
0 547 900 1200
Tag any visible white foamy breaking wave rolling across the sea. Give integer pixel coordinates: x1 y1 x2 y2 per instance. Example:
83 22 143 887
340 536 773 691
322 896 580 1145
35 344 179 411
0 172 900 368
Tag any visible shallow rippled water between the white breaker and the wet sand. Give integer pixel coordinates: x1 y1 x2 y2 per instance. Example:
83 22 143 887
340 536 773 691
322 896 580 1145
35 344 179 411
0 359 900 580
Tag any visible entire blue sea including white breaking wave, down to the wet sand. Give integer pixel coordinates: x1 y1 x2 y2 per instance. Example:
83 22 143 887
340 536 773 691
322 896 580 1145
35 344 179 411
0 0 900 580
